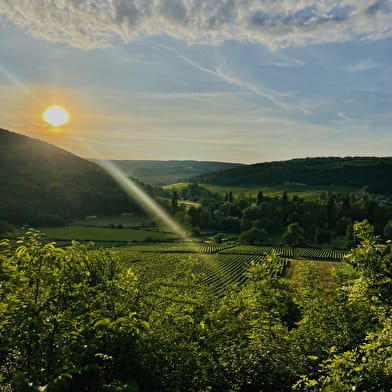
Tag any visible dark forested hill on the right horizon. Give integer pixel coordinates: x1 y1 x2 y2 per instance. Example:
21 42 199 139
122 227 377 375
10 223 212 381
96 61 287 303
192 157 392 194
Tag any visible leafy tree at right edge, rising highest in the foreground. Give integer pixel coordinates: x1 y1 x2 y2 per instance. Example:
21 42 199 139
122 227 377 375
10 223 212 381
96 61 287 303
294 220 392 392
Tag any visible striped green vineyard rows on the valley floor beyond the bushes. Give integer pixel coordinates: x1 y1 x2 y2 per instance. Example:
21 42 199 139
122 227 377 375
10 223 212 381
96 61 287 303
113 243 347 296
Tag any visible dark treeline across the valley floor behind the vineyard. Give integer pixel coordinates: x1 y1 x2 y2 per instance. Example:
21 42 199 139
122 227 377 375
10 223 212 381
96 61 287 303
167 183 392 246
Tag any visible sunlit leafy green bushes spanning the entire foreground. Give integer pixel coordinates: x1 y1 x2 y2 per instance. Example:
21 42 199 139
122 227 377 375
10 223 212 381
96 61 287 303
0 222 392 392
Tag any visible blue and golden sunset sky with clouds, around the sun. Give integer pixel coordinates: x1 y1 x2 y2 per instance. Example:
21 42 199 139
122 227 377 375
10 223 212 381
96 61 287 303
0 0 392 163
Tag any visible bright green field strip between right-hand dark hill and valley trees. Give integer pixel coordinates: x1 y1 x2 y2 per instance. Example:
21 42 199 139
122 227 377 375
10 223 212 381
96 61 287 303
164 182 356 201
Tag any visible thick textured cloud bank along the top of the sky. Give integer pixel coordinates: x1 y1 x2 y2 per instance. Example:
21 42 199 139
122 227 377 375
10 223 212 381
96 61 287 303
0 0 392 49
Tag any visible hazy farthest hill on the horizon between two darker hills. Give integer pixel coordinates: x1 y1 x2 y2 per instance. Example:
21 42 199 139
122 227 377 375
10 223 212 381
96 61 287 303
92 159 242 186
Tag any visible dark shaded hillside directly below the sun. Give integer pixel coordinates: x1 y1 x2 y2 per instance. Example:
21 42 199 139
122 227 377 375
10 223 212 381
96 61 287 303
0 129 136 225
